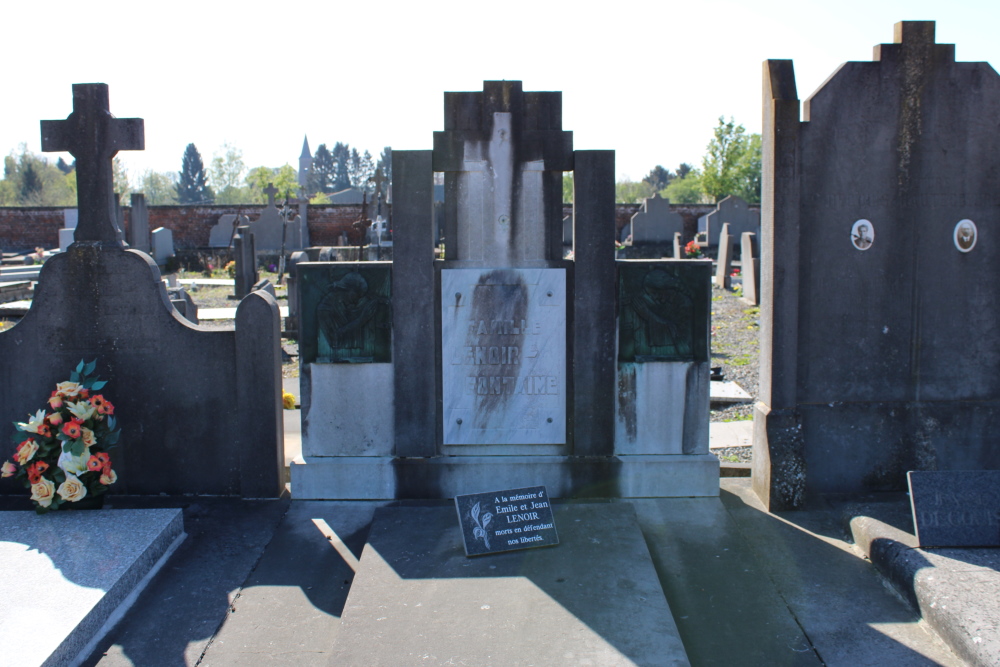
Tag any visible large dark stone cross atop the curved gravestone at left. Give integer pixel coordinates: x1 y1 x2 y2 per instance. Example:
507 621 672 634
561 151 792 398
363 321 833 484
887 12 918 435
42 83 145 246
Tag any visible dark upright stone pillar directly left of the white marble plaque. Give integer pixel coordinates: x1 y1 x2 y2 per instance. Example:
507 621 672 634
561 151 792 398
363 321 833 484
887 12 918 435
392 151 438 457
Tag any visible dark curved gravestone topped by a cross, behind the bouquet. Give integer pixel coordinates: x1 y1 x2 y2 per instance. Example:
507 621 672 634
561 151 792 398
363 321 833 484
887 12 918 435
0 84 284 497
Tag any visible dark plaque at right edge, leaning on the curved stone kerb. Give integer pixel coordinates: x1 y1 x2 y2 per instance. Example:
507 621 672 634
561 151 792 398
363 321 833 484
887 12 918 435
906 470 1000 547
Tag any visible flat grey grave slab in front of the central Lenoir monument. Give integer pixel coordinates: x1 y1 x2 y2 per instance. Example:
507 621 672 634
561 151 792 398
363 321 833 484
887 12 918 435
329 503 690 667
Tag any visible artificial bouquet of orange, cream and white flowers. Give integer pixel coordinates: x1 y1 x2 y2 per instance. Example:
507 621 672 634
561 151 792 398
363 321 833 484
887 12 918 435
0 359 121 514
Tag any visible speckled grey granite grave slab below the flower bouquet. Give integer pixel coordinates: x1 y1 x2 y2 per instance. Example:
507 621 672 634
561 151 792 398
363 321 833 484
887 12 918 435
0 509 184 667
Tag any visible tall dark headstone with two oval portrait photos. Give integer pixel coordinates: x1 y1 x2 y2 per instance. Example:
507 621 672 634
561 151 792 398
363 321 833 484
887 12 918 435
753 22 1000 510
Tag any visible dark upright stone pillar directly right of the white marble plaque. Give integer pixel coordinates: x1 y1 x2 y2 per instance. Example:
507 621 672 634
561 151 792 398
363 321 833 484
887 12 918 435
572 151 617 456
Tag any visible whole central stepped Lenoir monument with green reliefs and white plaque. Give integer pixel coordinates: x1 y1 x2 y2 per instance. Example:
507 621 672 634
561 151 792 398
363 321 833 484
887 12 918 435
292 81 718 499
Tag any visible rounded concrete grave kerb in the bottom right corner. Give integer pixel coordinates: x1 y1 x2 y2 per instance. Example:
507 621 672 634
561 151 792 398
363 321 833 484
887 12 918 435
850 508 1000 667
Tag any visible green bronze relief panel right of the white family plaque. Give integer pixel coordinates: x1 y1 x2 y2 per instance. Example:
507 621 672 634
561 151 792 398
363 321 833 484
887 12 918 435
618 260 712 362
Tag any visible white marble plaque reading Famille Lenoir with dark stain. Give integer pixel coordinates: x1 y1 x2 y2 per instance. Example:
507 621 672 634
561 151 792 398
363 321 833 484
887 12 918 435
441 269 566 445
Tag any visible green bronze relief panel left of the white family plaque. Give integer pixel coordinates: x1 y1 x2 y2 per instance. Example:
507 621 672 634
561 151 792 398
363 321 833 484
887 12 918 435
298 262 392 364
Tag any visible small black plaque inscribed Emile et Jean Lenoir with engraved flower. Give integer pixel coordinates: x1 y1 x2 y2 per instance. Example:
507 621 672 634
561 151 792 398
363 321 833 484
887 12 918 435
455 486 559 556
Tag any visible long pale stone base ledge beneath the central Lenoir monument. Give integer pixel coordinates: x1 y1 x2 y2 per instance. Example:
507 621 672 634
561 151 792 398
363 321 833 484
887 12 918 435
291 454 719 500
